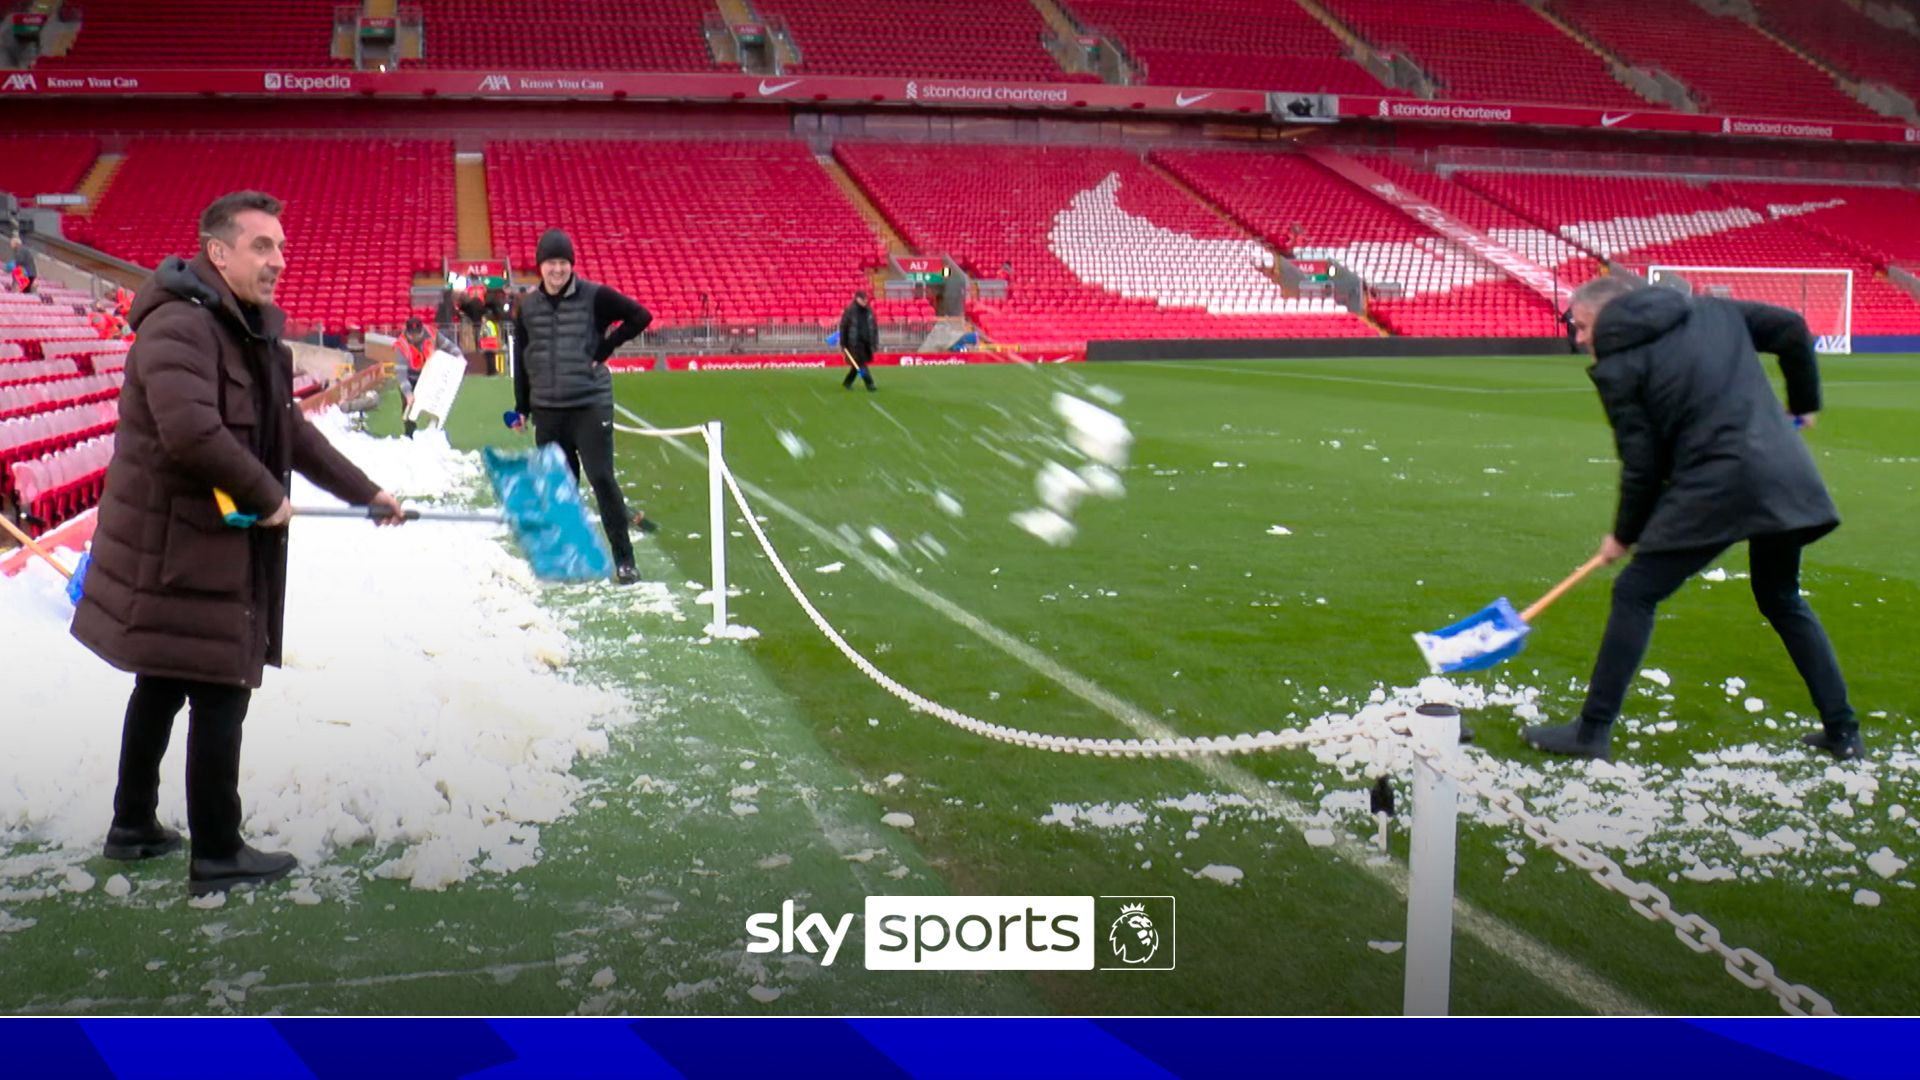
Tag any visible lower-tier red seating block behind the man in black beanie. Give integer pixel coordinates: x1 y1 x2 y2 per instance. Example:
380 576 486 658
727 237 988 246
488 140 931 329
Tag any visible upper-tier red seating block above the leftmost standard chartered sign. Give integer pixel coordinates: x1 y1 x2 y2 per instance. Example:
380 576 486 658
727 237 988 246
756 0 1098 83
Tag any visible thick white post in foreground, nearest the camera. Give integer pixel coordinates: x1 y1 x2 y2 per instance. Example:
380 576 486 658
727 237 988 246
1402 705 1459 1017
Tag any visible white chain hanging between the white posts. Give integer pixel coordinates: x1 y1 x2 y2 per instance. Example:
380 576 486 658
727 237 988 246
620 427 1836 1017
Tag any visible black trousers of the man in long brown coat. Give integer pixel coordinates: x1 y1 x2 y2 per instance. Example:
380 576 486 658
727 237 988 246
113 675 253 859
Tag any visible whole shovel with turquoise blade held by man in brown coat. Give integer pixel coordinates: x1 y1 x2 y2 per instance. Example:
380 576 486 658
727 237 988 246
213 446 612 580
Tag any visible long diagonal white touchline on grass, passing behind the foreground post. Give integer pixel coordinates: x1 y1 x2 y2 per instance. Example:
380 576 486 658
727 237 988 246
614 405 1653 1017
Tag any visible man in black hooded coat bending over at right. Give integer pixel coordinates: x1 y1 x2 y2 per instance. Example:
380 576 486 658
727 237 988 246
1526 277 1862 761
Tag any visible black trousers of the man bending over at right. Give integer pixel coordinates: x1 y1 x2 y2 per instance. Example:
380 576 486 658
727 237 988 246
1580 534 1855 726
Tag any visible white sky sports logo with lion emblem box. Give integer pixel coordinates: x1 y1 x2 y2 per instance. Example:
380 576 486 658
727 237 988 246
747 896 1175 970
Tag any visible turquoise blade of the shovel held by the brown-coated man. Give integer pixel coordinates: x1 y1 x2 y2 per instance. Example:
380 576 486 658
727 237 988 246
482 444 612 580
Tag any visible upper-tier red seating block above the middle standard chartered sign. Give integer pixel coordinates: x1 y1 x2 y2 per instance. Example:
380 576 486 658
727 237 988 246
1323 0 1651 110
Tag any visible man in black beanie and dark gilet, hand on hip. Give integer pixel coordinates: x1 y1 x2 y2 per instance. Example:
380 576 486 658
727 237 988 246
513 229 653 584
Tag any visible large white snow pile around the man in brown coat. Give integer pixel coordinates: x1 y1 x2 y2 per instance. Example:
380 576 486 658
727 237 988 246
0 415 632 888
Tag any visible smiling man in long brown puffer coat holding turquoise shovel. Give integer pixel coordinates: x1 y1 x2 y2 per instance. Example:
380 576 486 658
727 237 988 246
73 192 401 896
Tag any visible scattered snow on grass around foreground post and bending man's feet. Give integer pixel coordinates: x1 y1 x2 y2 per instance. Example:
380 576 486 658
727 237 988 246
1039 669 1920 905
